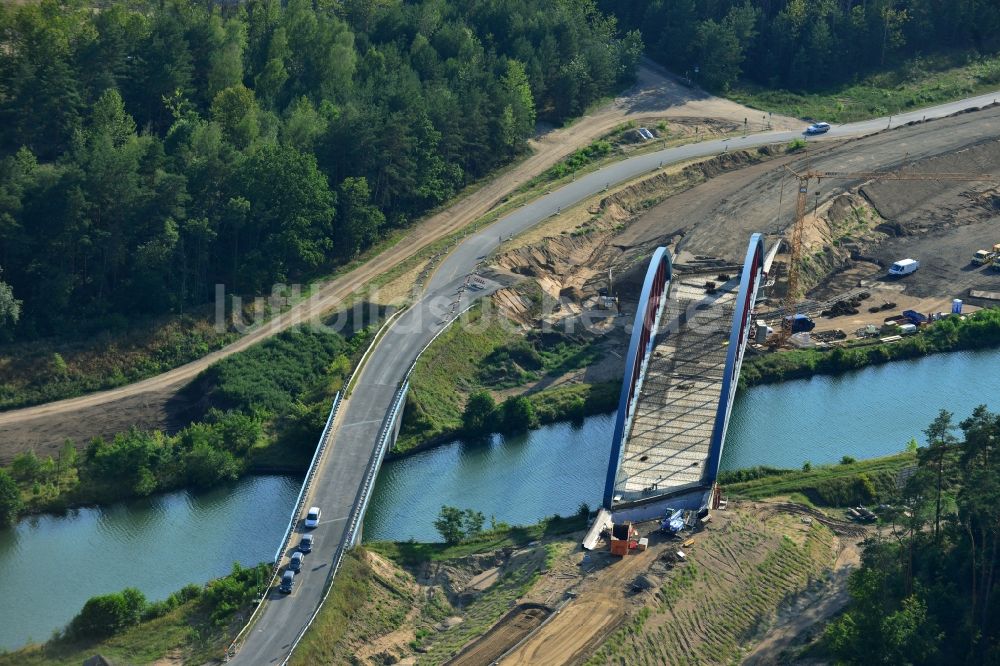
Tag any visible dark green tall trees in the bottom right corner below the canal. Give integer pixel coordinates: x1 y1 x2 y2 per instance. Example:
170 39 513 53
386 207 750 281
825 406 1000 664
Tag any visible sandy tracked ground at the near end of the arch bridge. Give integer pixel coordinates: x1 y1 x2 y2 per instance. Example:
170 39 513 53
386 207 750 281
484 503 865 665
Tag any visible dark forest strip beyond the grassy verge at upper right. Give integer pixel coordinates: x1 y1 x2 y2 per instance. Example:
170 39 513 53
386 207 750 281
599 0 1000 90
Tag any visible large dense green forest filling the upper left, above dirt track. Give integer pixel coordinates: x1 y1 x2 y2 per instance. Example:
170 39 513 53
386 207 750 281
0 0 642 339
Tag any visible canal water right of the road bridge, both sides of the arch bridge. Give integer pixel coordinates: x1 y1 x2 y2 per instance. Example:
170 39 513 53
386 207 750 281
365 350 1000 541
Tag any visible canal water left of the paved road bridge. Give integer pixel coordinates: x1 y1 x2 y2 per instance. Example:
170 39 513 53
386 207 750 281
0 476 302 650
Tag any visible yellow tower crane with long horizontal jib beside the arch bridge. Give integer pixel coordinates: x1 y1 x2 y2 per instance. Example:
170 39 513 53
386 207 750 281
775 166 996 346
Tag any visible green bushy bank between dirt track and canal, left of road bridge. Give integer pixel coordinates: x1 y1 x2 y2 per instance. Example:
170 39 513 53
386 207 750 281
0 328 370 522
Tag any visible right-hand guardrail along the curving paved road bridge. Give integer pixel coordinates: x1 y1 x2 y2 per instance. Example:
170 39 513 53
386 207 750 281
281 299 478 666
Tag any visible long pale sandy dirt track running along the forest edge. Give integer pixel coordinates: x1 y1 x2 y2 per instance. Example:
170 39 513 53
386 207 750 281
0 62 801 456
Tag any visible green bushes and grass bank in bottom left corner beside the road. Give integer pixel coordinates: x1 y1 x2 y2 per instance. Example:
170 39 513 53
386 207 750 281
0 563 270 666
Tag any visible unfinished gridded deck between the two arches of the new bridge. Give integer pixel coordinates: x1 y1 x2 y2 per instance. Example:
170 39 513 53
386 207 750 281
615 278 738 500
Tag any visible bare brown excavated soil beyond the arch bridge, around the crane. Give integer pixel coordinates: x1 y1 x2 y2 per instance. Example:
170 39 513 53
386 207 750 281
614 107 1000 298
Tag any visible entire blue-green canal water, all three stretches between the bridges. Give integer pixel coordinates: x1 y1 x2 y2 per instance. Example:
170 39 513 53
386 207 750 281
0 351 1000 649
